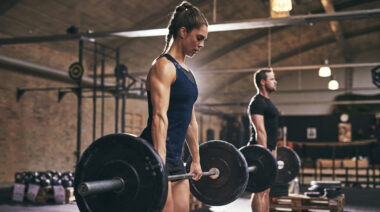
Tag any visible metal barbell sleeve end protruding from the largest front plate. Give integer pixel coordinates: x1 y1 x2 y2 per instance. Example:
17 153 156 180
78 177 125 197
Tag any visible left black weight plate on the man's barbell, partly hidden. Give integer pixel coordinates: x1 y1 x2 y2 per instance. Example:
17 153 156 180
240 145 277 193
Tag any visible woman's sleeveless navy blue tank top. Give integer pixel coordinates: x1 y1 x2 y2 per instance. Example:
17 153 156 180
141 54 198 162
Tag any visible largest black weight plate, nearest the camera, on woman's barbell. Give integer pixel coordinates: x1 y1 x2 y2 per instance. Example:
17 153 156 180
74 134 168 212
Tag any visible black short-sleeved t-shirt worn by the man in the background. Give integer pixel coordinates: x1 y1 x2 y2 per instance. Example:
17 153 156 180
248 94 279 150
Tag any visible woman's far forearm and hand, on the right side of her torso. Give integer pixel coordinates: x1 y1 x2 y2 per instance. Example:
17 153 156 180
186 108 202 180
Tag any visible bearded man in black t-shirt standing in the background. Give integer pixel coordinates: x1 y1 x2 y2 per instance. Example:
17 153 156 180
248 69 279 212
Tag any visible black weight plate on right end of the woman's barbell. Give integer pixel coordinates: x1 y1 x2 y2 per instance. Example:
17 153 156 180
186 140 248 205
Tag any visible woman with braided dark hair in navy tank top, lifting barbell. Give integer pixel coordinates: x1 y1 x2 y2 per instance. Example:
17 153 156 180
141 1 208 212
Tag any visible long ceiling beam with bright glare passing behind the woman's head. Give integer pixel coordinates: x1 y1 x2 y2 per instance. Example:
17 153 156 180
0 8 380 45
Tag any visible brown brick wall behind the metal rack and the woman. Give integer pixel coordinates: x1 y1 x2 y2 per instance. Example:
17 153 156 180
0 39 220 182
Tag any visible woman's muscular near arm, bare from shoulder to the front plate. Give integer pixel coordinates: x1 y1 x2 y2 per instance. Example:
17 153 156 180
147 58 176 163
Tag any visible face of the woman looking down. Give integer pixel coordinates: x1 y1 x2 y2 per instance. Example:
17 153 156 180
182 25 208 57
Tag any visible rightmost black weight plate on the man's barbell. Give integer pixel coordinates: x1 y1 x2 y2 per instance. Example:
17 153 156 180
276 147 301 184
